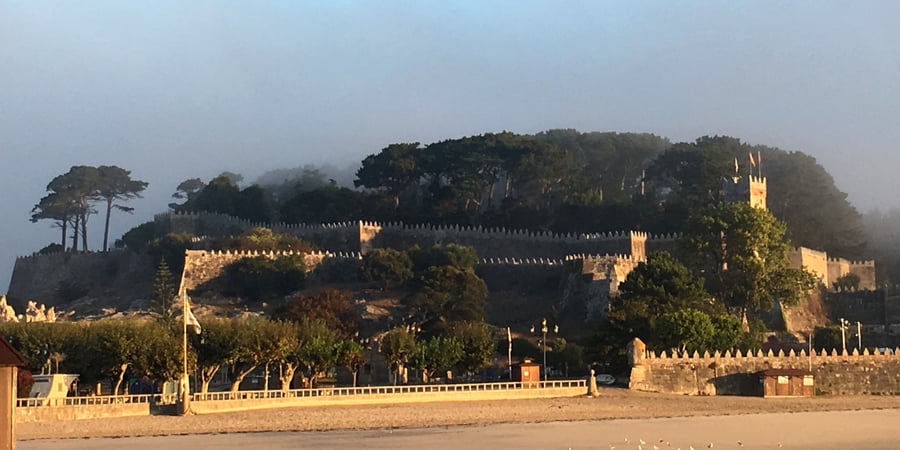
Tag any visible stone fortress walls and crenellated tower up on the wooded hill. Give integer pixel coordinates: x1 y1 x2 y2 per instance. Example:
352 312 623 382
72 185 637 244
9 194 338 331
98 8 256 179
3 176 880 329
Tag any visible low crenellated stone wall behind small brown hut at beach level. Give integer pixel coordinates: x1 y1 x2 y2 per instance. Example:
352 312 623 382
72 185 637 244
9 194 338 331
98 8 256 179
628 340 900 395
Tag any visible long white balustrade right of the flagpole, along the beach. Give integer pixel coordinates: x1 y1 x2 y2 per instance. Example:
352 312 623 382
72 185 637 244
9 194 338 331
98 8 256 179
191 380 587 401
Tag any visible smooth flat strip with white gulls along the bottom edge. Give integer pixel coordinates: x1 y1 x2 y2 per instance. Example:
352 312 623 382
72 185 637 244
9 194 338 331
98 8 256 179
18 410 900 450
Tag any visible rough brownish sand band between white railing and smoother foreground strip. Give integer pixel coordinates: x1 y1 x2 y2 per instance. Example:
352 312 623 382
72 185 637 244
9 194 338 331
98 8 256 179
16 388 900 441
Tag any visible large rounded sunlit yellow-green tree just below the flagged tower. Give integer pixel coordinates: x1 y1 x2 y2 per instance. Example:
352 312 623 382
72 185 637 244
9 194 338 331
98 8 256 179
681 203 816 317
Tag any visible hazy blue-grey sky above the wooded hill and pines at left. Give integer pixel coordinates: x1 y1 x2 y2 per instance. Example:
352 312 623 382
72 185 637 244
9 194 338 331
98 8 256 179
0 0 900 293
